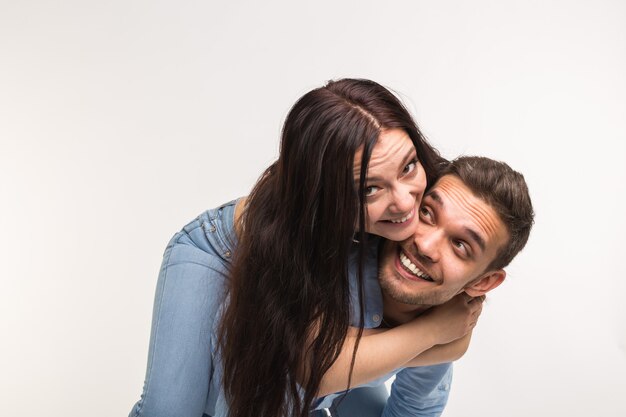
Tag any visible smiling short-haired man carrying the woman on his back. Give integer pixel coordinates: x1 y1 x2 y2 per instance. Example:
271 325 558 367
322 157 534 417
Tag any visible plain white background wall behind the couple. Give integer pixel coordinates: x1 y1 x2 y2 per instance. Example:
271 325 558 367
0 0 626 417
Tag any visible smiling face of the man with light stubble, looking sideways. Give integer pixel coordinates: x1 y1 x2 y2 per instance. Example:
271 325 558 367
379 175 508 305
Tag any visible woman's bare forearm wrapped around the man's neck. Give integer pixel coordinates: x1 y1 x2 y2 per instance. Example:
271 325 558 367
318 294 482 397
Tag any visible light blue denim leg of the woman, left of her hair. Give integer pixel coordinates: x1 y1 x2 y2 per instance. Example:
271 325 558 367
129 211 233 417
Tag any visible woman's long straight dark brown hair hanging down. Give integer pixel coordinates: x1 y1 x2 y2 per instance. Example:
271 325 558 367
219 79 440 417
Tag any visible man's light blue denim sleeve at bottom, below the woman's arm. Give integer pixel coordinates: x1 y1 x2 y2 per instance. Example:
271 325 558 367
382 363 452 417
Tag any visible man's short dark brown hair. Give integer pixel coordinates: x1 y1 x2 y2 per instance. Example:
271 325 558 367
441 156 535 270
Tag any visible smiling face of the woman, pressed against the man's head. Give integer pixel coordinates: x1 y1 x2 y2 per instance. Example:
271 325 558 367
354 129 426 241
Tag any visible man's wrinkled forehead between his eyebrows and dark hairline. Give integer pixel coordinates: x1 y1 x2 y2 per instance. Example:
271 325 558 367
426 174 508 249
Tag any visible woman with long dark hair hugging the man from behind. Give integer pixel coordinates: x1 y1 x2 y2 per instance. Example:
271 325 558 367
131 79 478 417
